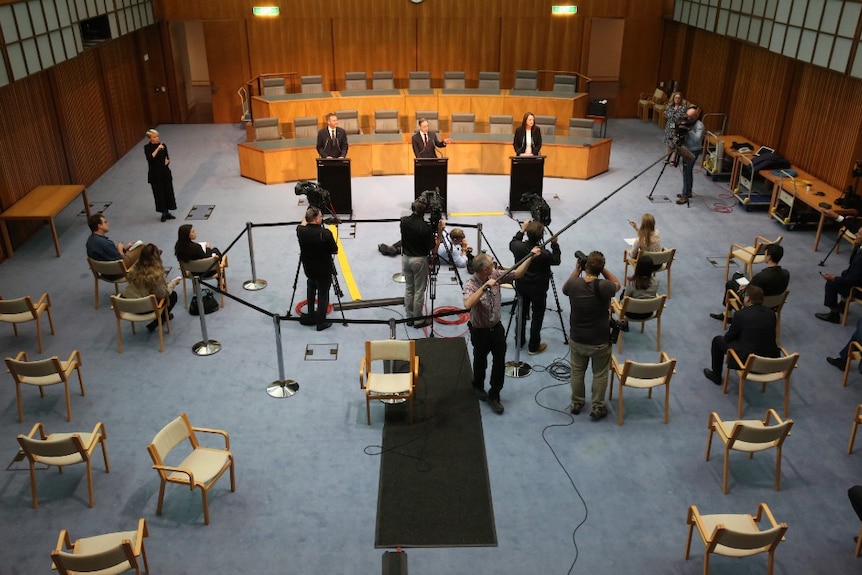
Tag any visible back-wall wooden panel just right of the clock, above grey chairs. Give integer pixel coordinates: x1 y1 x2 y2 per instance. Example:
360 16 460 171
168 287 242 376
415 18 501 84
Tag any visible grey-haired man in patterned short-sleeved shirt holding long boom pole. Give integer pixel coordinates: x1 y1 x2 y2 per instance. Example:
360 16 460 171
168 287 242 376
464 247 540 415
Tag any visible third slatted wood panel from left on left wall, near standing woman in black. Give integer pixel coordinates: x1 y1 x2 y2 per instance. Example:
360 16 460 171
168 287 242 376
98 35 147 158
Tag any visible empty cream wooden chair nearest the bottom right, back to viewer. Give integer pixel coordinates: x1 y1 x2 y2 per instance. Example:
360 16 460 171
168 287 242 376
685 503 787 575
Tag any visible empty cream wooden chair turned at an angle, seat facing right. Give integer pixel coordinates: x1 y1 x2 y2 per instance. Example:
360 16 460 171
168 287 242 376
147 413 236 525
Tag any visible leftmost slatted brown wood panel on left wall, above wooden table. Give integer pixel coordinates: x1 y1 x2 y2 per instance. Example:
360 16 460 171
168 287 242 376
0 72 71 259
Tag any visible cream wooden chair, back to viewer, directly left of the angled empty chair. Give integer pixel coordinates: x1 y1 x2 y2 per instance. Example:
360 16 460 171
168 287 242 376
18 421 111 509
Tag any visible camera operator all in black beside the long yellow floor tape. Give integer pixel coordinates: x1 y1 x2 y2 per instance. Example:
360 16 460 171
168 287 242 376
296 206 338 331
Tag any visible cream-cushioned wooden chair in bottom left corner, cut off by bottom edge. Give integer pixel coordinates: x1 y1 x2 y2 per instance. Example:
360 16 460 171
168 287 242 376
51 517 150 575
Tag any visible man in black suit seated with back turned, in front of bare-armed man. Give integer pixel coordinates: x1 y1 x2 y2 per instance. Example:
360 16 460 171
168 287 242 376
703 285 781 385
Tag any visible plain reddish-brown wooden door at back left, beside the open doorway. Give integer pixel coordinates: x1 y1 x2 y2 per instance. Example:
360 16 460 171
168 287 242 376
203 20 251 124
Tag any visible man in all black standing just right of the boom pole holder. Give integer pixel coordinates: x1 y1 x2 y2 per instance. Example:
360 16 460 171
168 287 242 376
509 220 561 355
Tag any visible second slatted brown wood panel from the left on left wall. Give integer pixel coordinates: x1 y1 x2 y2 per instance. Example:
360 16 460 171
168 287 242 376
48 50 117 186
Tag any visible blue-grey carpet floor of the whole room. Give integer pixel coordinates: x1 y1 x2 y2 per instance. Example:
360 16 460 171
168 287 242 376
0 120 862 575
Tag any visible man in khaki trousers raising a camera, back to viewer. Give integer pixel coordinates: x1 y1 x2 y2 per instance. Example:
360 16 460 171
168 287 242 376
563 252 620 421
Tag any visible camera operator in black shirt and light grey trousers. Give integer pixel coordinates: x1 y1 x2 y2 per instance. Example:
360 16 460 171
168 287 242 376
401 196 446 329
